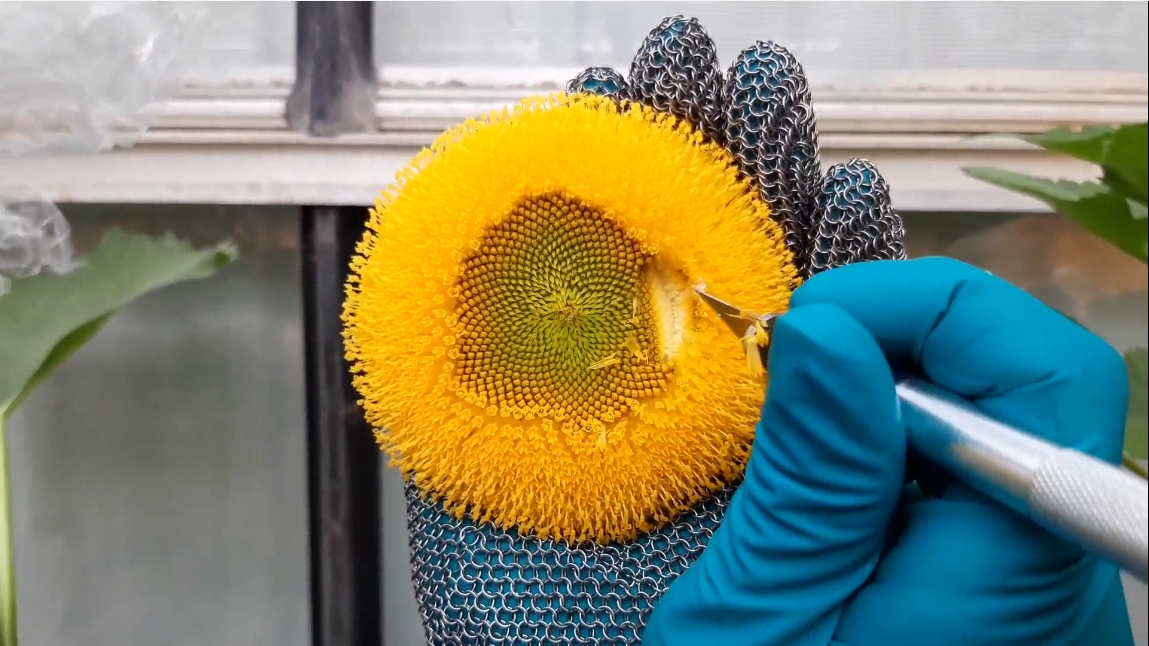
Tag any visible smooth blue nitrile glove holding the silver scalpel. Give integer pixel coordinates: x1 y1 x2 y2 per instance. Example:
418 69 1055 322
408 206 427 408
642 259 1133 646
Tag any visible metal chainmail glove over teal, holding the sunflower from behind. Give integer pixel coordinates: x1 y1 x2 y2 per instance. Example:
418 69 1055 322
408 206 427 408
406 16 905 646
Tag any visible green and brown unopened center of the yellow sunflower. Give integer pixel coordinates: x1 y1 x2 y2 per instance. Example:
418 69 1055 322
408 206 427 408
455 193 665 424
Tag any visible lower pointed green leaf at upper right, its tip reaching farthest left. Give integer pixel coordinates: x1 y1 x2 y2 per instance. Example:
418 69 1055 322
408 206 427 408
962 167 1149 262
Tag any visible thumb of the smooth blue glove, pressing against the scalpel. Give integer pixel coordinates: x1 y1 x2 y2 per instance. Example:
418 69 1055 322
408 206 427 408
642 306 905 646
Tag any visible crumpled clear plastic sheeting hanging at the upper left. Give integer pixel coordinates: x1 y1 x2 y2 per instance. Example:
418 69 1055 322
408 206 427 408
0 2 205 294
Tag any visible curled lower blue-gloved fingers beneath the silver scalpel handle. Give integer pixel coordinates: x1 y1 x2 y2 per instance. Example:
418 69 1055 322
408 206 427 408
835 485 1132 646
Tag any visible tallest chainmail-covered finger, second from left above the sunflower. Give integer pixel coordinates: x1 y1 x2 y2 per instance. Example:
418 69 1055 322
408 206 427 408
629 16 724 144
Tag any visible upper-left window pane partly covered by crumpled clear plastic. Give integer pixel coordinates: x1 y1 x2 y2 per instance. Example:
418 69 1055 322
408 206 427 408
0 2 295 155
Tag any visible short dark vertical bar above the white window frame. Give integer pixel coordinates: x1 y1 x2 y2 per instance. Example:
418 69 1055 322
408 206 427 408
286 2 377 137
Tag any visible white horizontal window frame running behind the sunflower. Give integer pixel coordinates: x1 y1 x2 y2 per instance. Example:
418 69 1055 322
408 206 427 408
0 68 1149 213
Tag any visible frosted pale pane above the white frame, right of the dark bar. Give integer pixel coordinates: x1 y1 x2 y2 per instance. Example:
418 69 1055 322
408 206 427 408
376 1 1149 77
